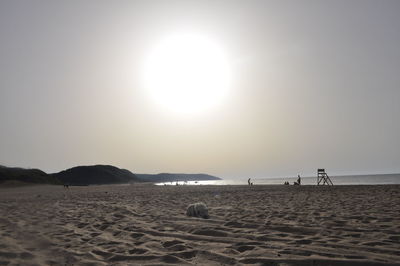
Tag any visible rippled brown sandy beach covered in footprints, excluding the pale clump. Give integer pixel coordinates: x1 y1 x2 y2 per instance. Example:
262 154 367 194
0 185 400 265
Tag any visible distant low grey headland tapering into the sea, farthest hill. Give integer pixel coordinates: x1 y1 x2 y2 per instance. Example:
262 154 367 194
136 173 221 183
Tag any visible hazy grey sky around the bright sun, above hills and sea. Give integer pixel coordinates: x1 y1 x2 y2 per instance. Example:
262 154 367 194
0 0 400 178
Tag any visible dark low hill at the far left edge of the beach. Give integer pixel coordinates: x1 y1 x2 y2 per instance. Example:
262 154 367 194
0 165 61 184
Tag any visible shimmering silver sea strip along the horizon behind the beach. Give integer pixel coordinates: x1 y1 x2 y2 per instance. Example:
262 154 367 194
156 174 400 186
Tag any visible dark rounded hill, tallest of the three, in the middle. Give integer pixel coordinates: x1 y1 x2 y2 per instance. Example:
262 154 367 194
53 165 139 185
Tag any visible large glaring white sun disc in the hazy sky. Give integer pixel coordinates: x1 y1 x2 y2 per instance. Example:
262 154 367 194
143 34 231 114
